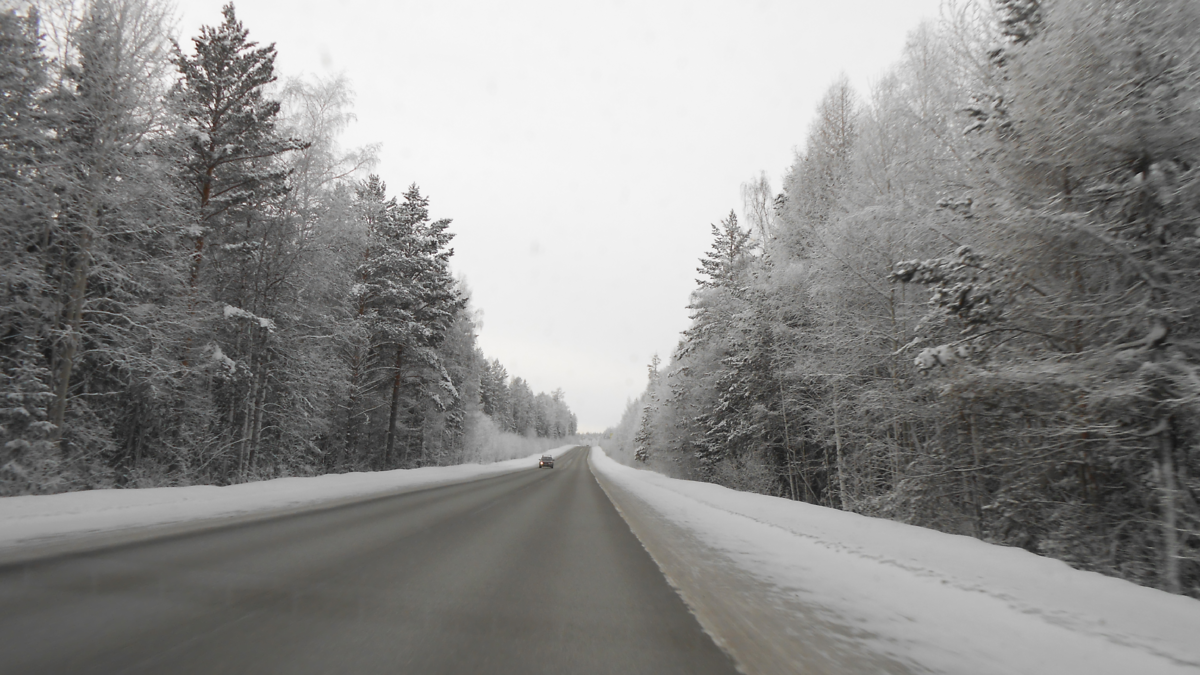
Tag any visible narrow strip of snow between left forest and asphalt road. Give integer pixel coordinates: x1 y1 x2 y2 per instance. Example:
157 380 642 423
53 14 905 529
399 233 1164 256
0 446 575 562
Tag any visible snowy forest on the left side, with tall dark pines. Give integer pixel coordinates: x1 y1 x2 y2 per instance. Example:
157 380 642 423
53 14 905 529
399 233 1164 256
0 0 576 495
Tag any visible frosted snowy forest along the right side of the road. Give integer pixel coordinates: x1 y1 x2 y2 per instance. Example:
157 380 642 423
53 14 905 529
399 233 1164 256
602 0 1200 597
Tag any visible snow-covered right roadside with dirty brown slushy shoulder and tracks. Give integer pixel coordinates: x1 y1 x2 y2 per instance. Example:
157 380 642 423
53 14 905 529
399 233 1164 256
590 447 1200 675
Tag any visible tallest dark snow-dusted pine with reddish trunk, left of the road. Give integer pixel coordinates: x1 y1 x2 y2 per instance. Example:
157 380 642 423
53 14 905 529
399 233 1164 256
169 4 321 477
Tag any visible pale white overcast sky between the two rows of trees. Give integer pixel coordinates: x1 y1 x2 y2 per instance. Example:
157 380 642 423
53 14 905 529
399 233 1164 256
179 0 941 431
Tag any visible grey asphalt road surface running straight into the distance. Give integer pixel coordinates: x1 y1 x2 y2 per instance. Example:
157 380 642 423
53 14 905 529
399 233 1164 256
0 449 736 675
